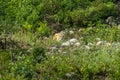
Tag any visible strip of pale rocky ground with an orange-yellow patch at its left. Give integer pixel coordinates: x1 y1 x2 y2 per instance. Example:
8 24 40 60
48 25 120 54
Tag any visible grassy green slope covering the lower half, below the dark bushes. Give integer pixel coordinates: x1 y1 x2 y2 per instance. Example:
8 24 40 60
0 27 120 80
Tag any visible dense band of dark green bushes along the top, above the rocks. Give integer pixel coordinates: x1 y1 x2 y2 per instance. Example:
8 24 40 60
0 0 118 29
